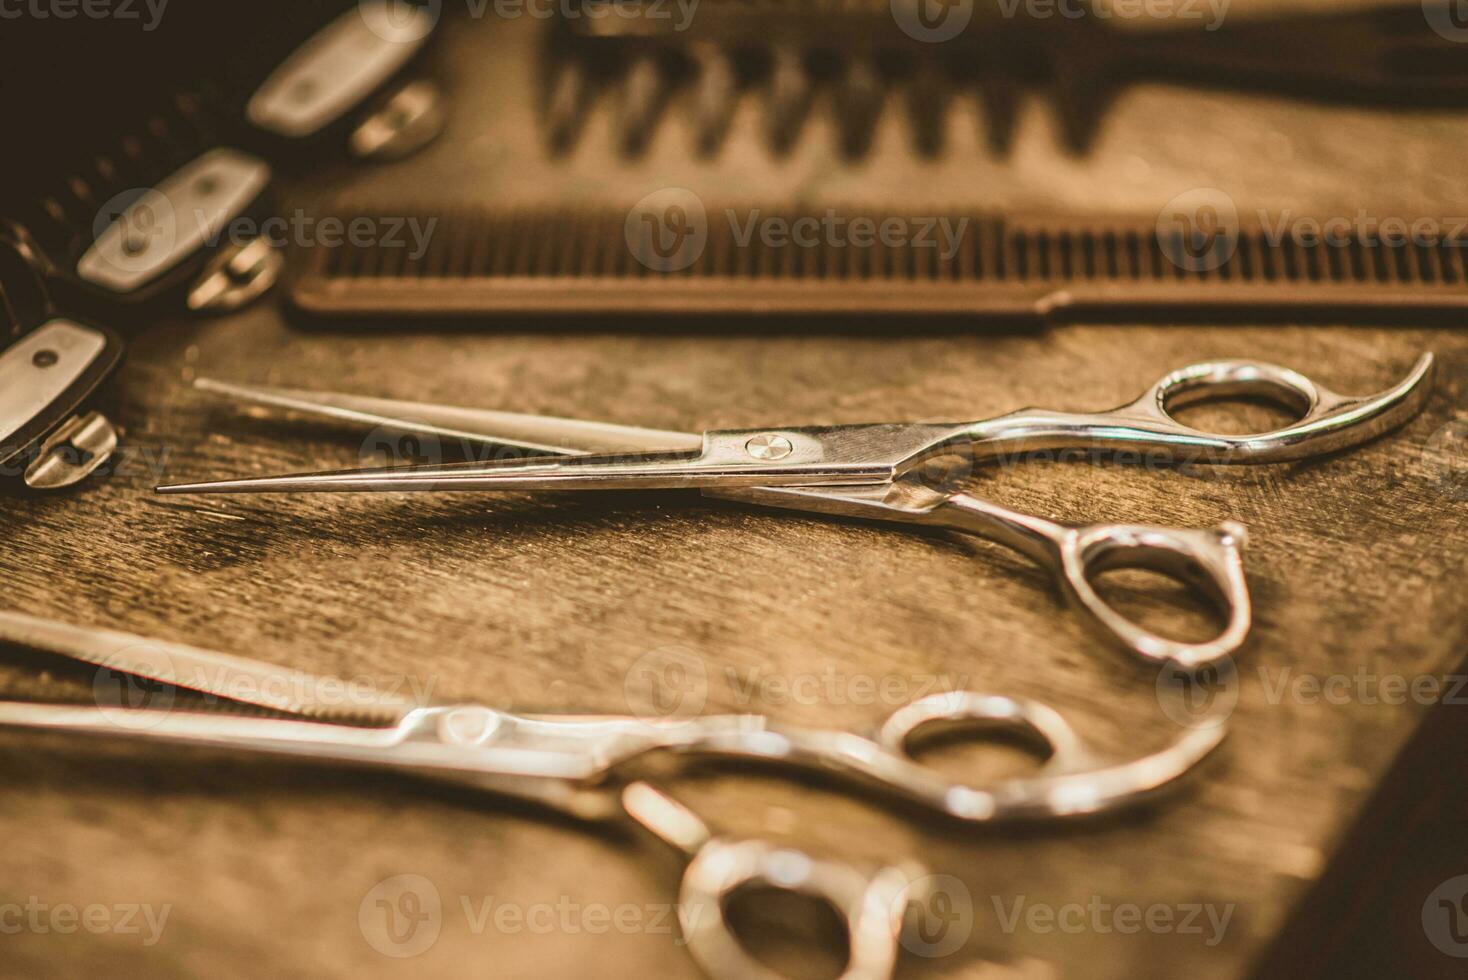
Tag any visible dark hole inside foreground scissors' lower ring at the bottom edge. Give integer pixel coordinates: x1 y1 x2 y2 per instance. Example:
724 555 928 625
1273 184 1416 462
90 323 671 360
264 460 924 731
722 883 851 980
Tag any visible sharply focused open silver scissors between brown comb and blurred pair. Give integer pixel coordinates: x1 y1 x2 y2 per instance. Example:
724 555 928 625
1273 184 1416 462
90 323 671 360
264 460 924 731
159 354 1433 672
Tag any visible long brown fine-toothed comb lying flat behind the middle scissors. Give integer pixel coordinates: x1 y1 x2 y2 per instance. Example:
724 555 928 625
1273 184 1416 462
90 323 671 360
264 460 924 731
294 207 1468 315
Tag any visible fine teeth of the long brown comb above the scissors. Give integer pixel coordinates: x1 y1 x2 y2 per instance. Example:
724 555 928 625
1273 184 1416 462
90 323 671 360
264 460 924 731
310 212 1468 286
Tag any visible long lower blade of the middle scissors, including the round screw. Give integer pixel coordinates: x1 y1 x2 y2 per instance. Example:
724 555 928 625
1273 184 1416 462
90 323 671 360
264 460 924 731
159 424 954 493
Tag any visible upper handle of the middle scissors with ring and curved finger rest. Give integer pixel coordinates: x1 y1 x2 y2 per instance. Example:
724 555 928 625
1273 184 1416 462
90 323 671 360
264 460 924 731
969 354 1434 464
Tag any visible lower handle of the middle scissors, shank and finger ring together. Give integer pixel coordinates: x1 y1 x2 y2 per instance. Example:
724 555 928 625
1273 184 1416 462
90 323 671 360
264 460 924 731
926 493 1252 672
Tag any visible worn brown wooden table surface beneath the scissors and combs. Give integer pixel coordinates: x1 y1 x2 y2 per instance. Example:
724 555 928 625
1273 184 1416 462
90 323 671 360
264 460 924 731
0 7 1468 980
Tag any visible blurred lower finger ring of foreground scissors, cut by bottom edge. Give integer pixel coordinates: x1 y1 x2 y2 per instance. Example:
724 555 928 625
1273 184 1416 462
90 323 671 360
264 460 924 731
678 838 912 980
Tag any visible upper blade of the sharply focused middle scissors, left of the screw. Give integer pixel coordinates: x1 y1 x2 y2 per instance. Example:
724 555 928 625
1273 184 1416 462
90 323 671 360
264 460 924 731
194 379 703 455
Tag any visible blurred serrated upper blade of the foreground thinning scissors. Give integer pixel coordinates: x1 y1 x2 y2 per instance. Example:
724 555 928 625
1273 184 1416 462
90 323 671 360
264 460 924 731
0 612 418 723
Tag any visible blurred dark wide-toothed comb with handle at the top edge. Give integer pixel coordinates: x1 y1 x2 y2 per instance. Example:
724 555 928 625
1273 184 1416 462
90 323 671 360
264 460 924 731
542 0 1468 157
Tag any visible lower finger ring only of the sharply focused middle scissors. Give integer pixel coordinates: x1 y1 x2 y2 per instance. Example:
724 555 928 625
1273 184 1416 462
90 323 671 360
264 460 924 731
1057 521 1254 673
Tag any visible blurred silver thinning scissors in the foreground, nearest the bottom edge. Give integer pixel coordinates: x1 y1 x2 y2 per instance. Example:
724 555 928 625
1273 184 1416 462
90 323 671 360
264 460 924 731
0 612 1226 980
